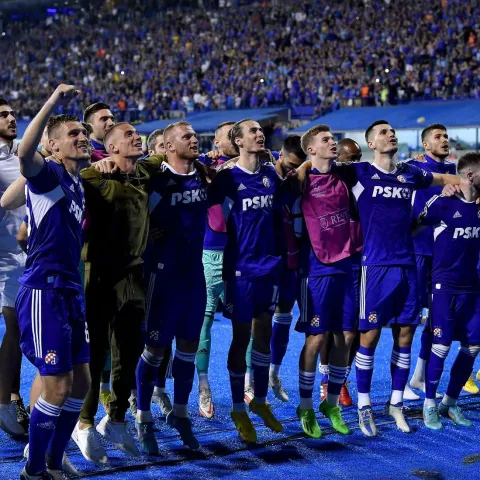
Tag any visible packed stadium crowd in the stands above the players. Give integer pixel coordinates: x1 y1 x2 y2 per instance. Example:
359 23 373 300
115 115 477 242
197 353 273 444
0 0 480 121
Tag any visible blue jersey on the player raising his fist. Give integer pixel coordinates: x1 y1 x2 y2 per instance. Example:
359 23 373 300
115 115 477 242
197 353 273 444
19 160 85 291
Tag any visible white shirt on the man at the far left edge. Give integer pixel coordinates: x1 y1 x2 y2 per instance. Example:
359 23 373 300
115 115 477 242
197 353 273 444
0 141 25 257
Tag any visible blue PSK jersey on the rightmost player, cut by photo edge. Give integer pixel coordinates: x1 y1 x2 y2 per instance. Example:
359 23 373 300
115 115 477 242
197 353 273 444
417 195 480 293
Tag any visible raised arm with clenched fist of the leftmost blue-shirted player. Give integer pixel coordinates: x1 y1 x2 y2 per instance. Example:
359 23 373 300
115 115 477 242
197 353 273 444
18 84 80 178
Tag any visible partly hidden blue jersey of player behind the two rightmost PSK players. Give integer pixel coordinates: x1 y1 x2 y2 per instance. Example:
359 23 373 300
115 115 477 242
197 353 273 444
408 155 456 256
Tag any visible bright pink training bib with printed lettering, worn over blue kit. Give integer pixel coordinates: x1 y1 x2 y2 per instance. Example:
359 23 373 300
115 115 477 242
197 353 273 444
302 173 355 264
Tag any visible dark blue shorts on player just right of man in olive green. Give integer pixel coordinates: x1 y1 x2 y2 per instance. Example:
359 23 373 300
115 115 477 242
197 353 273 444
145 268 207 348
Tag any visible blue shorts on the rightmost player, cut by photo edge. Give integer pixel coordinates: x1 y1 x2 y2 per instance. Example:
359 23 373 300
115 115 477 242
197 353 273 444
429 293 480 345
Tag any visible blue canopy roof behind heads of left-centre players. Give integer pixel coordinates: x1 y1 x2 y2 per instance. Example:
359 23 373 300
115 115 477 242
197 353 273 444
136 107 288 134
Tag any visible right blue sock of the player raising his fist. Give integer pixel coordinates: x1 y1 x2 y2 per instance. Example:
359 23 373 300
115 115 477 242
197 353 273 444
47 398 83 470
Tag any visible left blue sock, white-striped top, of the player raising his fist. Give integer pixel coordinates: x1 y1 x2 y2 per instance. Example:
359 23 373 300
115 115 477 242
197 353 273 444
27 397 62 475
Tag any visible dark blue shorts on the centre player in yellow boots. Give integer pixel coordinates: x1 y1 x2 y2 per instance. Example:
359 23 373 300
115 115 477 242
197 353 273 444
223 275 278 323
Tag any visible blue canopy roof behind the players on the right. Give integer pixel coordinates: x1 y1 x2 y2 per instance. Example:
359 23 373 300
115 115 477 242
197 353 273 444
291 100 480 133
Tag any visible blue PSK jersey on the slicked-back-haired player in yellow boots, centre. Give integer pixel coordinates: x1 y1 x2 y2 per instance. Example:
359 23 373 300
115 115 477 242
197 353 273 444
209 163 284 279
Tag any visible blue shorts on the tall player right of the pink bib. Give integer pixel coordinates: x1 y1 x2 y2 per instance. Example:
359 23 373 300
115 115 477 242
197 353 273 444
358 265 420 331
